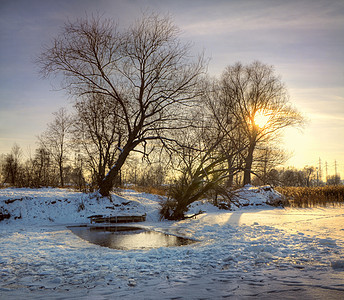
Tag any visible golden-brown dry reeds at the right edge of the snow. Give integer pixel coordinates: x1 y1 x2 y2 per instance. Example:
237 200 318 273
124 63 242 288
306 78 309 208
275 186 344 207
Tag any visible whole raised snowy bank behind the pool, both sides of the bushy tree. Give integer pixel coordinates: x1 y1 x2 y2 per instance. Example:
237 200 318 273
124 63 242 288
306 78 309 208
0 185 283 224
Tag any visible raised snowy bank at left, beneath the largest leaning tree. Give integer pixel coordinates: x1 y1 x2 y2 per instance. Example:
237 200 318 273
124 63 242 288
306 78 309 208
0 188 154 224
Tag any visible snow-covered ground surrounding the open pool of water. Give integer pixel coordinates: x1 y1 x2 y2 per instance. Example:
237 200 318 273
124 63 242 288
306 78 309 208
0 188 344 299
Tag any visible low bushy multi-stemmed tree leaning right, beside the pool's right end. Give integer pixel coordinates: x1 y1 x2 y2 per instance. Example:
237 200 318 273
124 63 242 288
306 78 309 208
160 105 241 220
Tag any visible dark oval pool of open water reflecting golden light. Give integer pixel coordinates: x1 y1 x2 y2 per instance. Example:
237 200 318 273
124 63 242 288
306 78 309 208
68 226 195 250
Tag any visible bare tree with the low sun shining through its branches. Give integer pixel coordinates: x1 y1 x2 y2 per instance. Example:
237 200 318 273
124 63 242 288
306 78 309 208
219 61 304 184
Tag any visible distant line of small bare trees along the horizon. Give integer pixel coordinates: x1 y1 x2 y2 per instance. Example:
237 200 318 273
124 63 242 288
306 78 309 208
0 144 342 190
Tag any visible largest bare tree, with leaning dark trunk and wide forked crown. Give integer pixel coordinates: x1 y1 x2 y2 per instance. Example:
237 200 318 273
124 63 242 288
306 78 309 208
38 14 204 196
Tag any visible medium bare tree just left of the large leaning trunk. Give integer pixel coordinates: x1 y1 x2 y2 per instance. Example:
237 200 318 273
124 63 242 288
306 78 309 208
72 94 125 187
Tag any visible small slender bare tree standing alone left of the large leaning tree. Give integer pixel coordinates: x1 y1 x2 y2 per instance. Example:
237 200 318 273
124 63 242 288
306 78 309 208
38 108 73 187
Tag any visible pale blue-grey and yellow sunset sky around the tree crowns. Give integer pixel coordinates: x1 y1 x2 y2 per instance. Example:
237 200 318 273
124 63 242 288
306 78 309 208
0 0 344 177
